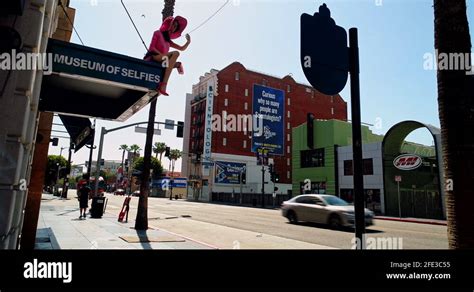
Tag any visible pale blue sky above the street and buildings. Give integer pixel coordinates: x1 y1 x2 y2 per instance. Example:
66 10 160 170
50 0 474 168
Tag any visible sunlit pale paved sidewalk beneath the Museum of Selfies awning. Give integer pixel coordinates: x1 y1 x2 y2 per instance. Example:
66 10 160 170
35 193 212 250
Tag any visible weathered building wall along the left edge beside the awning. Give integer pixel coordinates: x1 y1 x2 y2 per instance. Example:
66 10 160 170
0 0 62 249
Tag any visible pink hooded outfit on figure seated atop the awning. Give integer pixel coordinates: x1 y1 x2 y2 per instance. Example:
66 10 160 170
145 16 188 61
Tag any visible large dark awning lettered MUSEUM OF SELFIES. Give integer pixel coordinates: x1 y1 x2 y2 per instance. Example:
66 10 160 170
40 39 164 121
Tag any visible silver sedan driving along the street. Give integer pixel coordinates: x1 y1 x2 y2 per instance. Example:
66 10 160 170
281 194 374 228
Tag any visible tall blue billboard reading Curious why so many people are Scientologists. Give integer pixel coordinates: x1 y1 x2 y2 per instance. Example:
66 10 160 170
252 84 285 155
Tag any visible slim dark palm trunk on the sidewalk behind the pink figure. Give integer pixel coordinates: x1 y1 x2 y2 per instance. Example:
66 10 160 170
135 0 175 230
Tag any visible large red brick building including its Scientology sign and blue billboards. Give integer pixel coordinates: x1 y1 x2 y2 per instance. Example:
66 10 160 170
183 62 347 201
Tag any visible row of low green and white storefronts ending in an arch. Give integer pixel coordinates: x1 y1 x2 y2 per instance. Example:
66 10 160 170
293 120 445 219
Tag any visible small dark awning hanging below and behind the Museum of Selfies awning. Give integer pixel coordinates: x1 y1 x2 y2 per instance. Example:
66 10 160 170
59 115 95 152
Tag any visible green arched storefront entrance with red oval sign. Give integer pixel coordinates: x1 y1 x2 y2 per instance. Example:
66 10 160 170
382 121 446 219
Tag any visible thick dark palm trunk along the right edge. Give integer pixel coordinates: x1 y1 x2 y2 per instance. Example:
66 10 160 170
434 0 474 249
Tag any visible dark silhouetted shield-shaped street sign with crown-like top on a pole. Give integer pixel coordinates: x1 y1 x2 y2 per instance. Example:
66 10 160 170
301 4 349 95
